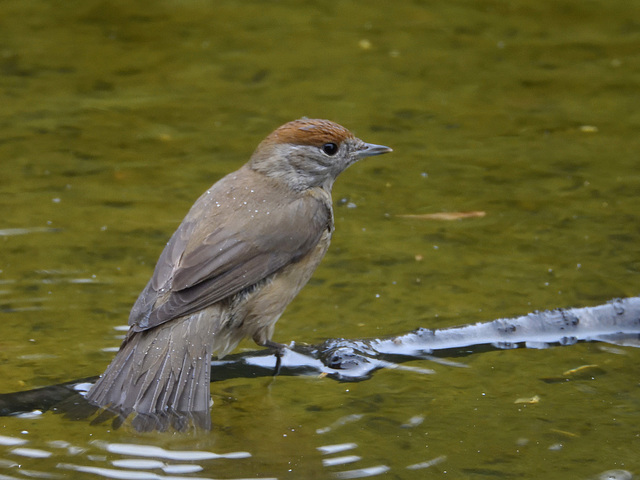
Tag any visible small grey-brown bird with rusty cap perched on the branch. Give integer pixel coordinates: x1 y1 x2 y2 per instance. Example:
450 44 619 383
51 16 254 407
87 118 391 430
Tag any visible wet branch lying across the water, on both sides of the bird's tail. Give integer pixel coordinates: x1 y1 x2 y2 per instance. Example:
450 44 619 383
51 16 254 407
0 297 640 428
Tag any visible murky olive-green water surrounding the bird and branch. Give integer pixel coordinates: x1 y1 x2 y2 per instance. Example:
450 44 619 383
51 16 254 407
0 0 640 479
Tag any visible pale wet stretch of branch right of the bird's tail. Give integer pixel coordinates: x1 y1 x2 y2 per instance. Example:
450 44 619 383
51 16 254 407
219 297 640 381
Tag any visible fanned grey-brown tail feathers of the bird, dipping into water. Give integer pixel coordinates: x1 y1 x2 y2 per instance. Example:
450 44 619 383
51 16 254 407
87 314 213 430
